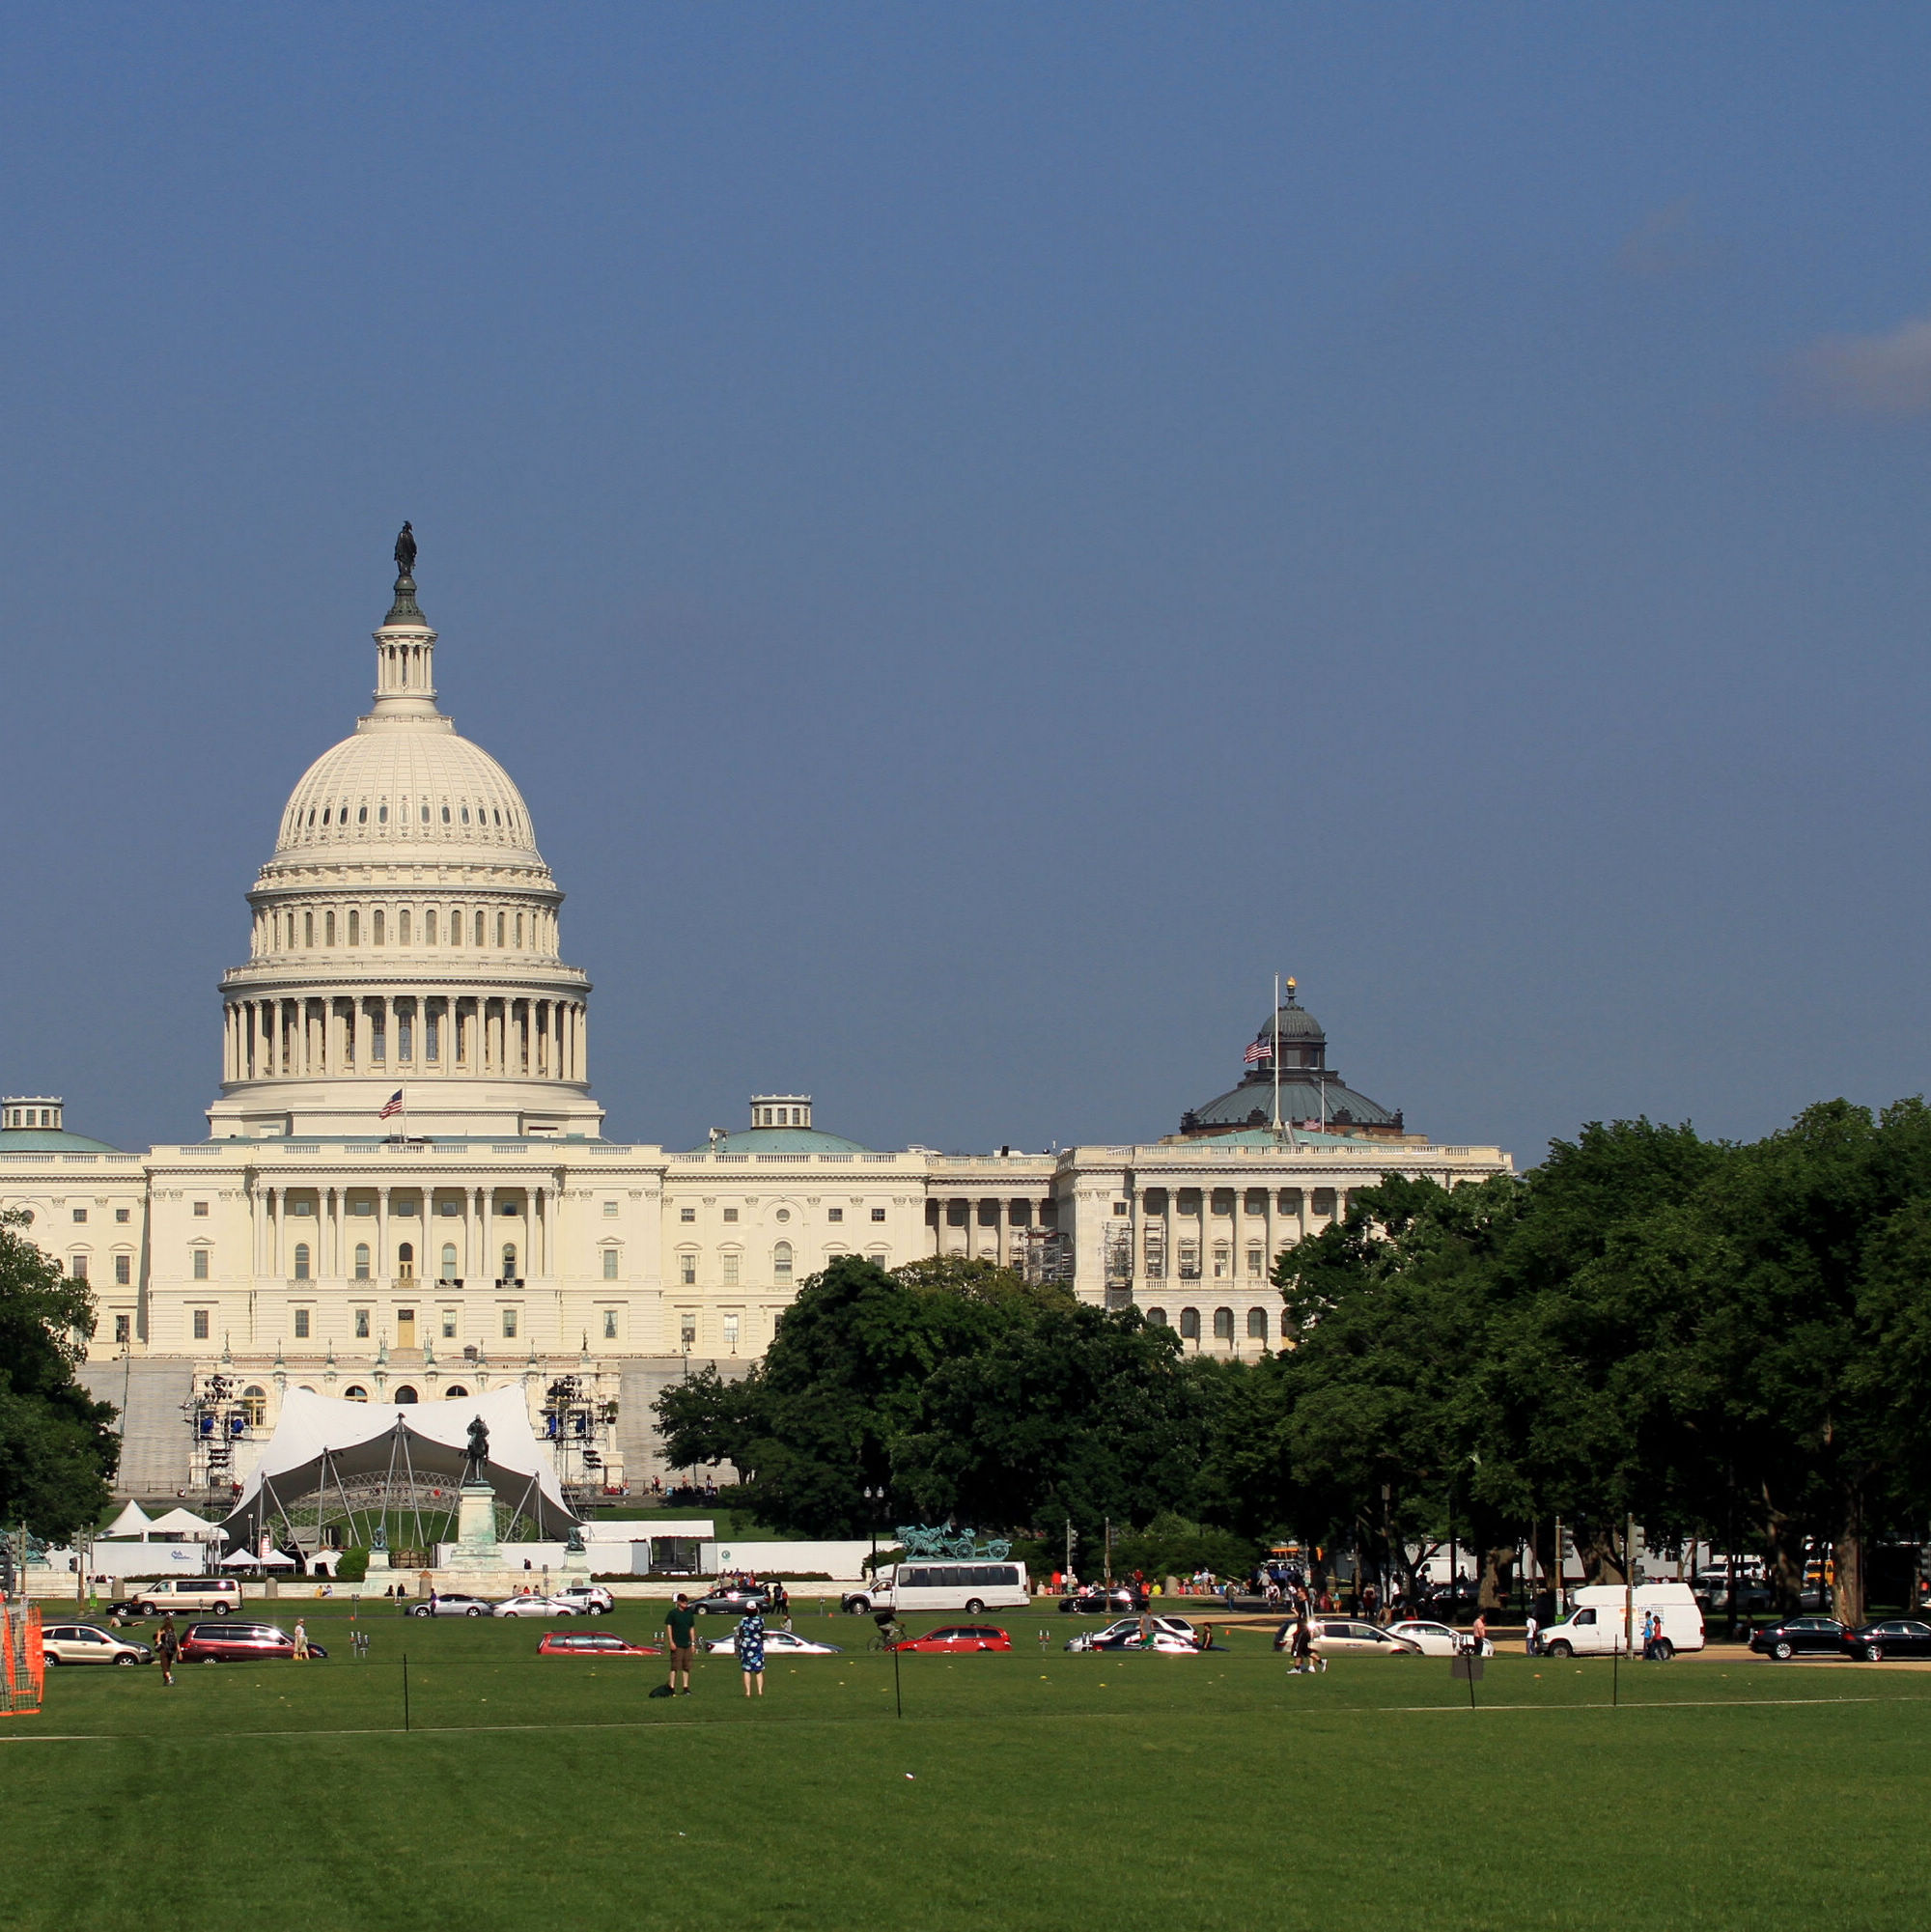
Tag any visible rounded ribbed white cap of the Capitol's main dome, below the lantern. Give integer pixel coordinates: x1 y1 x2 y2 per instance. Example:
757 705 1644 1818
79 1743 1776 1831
274 716 543 865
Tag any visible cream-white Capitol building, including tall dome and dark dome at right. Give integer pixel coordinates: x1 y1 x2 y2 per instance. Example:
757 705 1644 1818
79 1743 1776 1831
0 533 1510 1496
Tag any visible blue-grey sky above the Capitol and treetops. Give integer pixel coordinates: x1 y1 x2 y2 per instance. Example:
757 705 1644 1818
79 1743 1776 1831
0 4 1931 1162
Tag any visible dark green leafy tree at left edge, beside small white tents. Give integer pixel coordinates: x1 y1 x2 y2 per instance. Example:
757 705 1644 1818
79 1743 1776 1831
0 1210 120 1542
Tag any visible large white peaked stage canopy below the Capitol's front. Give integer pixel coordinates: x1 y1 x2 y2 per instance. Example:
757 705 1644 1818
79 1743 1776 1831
222 1384 577 1546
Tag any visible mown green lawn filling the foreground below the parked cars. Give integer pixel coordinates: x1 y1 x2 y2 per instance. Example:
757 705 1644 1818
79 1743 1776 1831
0 1602 1931 1932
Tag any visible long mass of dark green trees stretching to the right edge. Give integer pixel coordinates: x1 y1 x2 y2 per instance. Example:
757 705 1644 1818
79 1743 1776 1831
658 1100 1931 1621
